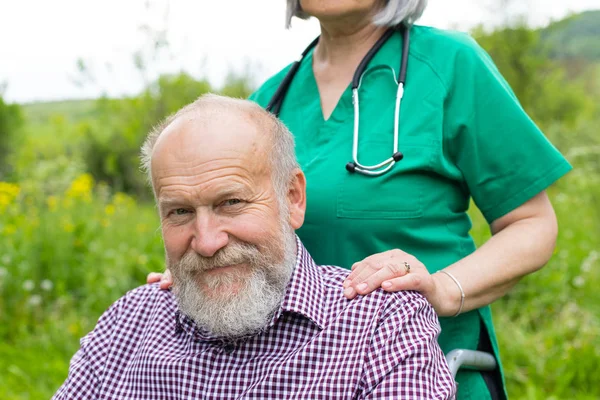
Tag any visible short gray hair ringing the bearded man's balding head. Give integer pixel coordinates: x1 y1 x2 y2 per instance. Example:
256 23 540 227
141 93 299 200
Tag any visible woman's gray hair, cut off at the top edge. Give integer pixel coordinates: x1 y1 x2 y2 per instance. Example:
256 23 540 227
285 0 427 29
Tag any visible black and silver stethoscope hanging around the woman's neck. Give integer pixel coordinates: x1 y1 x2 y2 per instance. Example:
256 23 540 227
267 24 410 176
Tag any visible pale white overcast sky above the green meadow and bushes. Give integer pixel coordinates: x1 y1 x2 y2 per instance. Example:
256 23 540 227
0 0 600 102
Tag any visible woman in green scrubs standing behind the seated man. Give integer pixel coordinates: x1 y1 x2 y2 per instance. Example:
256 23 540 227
150 0 571 400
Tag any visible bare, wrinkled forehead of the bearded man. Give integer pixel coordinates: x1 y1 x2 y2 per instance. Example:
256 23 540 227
151 113 272 198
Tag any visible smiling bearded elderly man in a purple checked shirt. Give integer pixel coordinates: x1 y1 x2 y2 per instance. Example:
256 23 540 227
55 95 455 400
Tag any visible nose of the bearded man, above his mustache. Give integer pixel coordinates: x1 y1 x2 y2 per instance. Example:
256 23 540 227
191 210 229 257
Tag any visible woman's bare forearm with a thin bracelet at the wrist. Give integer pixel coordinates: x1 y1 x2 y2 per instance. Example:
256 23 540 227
432 193 558 316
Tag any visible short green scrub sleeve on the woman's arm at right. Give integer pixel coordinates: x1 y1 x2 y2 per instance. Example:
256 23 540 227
444 37 571 223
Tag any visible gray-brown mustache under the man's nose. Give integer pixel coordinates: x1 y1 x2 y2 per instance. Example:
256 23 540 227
175 242 265 273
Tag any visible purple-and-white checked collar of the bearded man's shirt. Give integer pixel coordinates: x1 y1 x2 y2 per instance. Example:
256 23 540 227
175 236 326 343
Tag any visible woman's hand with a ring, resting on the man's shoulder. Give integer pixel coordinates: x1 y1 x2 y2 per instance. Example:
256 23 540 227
343 249 443 311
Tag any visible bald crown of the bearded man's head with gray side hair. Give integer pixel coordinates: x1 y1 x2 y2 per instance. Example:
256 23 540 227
142 94 298 195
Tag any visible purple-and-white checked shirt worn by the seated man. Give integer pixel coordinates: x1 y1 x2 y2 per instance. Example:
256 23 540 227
54 241 455 400
